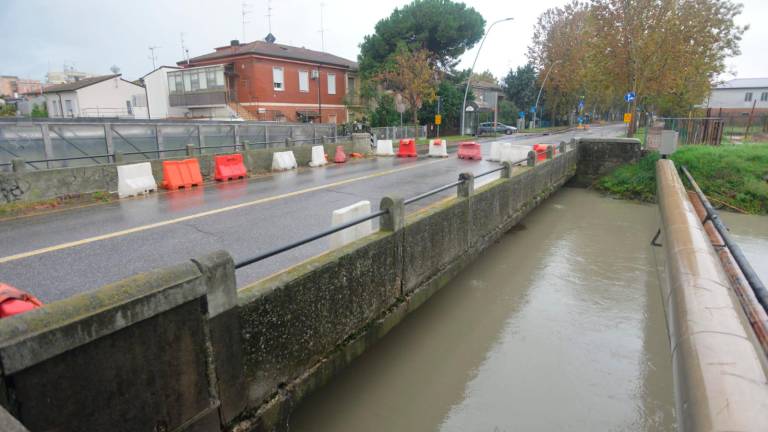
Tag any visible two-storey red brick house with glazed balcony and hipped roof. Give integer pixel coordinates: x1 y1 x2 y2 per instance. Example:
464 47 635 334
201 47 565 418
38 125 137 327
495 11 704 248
177 40 357 123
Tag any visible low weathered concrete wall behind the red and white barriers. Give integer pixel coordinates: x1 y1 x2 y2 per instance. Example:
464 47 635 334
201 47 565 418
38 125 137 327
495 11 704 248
0 140 354 205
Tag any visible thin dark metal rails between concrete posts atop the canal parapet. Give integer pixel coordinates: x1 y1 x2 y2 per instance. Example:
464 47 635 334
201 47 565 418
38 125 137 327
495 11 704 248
235 148 556 269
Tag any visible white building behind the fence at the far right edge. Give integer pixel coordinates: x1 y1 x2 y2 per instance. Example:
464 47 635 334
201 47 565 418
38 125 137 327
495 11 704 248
706 78 768 115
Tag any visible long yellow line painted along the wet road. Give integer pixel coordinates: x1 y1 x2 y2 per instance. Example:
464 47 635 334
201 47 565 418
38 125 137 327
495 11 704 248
0 159 449 264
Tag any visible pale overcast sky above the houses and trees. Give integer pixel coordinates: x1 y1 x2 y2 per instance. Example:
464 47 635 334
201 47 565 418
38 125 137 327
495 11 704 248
0 0 768 79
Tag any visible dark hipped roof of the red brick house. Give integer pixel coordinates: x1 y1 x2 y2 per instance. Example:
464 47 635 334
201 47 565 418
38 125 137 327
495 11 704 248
186 40 357 70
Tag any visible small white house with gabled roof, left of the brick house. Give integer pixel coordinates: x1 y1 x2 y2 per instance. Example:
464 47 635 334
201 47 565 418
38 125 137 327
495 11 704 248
43 74 149 119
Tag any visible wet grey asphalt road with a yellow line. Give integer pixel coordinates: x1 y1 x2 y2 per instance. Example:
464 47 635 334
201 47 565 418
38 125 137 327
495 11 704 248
0 125 623 302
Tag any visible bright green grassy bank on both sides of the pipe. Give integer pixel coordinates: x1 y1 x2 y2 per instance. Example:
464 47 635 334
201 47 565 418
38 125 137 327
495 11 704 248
595 144 768 215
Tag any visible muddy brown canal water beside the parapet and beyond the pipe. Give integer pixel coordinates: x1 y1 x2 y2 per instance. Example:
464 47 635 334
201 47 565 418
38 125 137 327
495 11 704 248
289 188 768 432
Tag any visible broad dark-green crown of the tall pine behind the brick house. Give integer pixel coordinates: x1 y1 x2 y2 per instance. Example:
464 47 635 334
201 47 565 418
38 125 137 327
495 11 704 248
358 0 485 76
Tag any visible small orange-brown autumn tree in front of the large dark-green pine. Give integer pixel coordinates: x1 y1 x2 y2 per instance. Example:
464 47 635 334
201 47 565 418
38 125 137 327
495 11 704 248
378 45 437 123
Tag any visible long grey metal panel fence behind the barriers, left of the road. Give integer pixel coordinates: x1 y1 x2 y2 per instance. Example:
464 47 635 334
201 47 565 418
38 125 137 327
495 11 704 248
0 120 340 171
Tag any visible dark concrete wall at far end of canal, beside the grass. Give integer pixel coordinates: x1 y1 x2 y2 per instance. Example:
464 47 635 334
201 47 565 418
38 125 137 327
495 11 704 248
574 138 641 186
